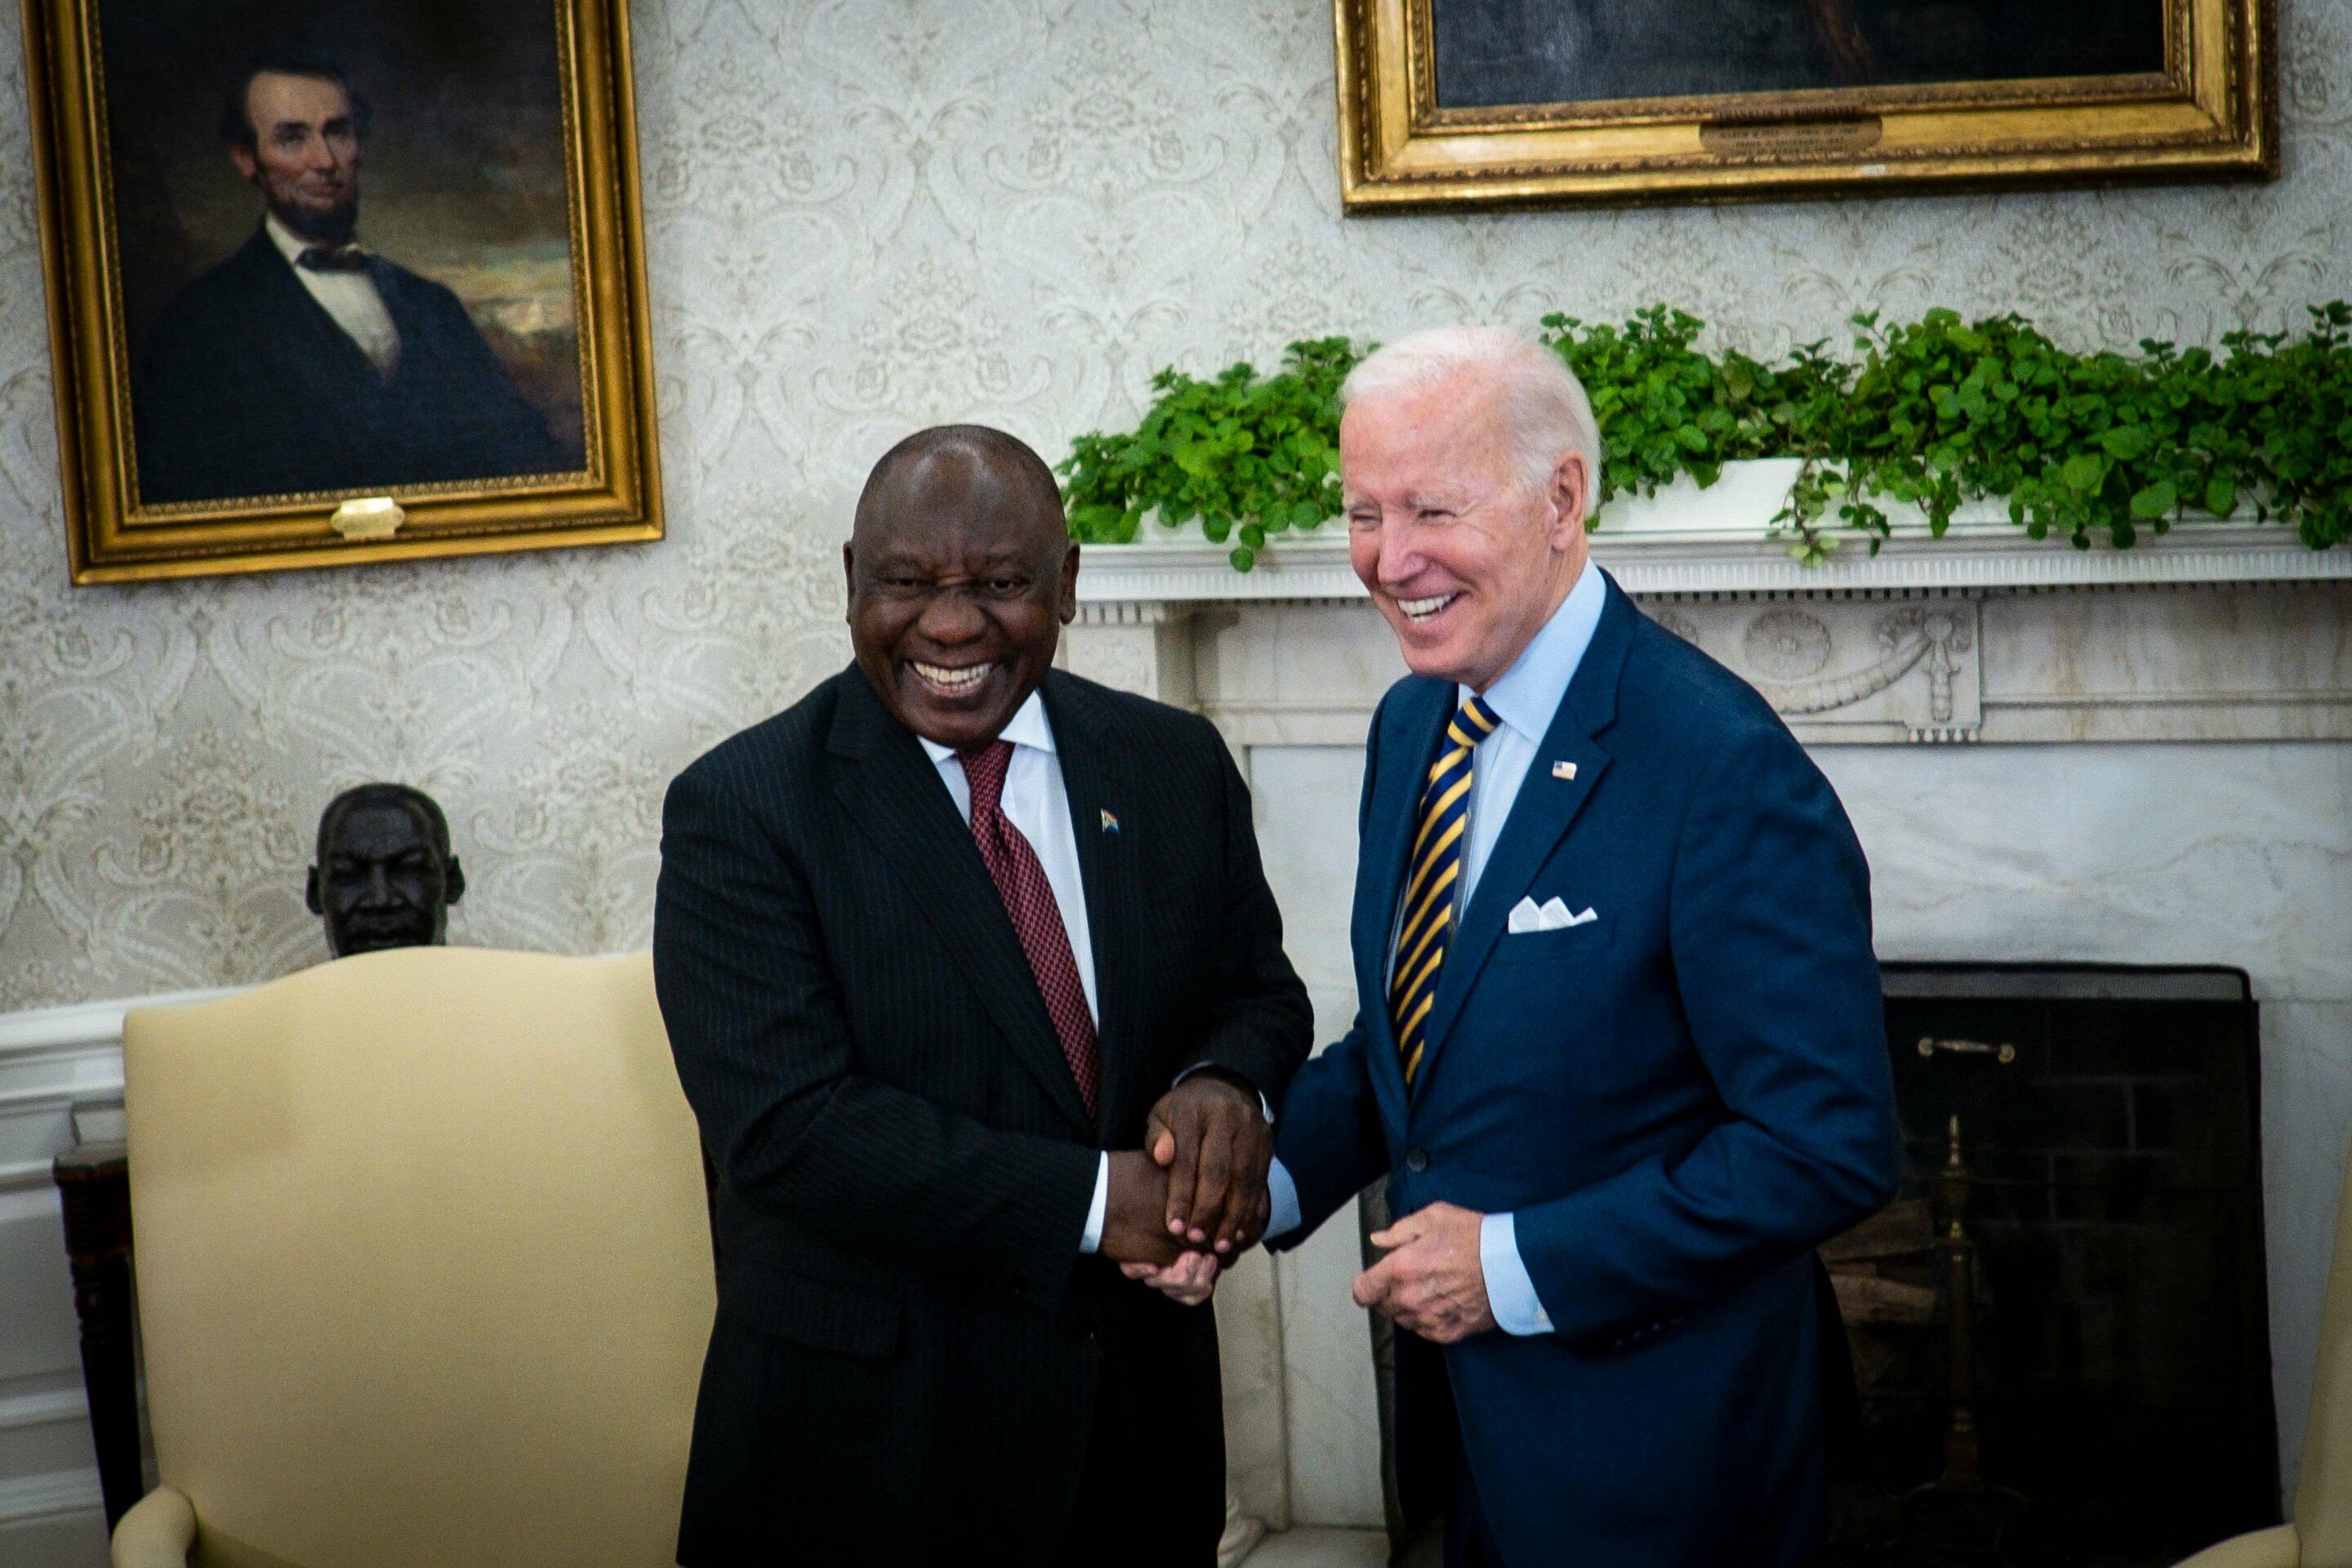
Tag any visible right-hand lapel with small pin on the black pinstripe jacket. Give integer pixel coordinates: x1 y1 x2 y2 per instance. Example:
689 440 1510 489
1045 670 1147 1138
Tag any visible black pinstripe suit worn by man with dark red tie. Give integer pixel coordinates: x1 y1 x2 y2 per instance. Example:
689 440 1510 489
654 668 1312 1568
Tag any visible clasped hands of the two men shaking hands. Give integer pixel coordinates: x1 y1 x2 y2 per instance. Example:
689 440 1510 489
1103 1067 1275 1307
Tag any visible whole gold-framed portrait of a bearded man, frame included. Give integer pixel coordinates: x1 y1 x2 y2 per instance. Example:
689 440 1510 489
21 0 663 583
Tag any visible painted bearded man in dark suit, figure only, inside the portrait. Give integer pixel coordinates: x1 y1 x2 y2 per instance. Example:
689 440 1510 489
134 45 568 506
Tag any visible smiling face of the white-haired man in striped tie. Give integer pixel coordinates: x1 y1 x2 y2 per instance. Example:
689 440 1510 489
1339 372 1585 691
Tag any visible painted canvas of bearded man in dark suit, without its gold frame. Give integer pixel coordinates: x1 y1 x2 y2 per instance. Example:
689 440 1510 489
96 0 586 508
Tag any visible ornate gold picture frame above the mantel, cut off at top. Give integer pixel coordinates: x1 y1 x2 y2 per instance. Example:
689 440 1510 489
1334 0 2279 214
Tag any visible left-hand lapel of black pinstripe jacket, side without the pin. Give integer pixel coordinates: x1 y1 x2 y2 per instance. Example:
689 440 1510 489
828 668 1101 1135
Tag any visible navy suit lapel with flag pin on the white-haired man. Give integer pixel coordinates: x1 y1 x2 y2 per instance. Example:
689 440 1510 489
1421 578 1639 1084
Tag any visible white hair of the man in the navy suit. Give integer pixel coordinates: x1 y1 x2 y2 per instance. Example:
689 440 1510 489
1339 327 1601 522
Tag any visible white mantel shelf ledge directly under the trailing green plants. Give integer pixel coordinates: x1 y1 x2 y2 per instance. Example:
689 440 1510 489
1077 461 2352 609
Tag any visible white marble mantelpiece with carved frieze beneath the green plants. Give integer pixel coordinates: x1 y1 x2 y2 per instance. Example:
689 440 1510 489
1066 463 2352 747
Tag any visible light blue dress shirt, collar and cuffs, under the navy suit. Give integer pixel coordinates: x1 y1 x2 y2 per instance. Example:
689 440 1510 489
1265 557 1609 1333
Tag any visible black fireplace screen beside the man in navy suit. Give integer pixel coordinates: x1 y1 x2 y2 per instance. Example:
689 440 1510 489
1825 964 2279 1568
